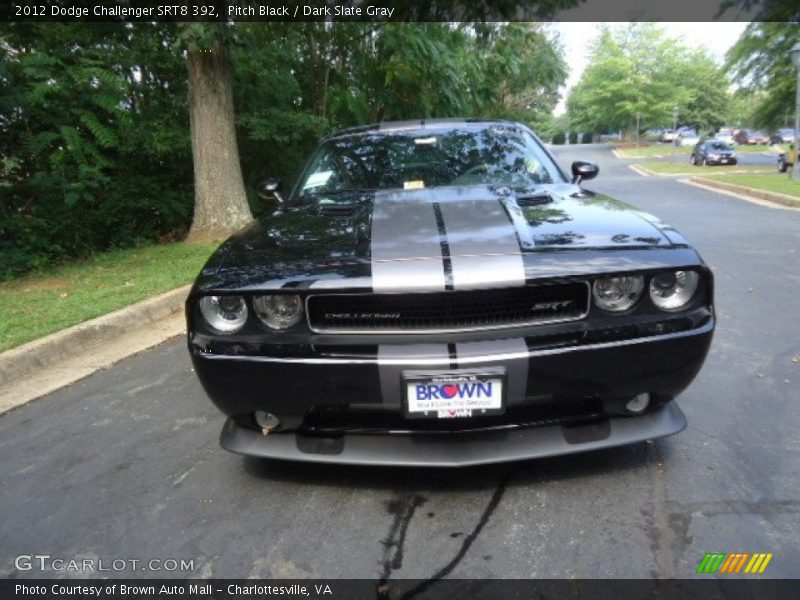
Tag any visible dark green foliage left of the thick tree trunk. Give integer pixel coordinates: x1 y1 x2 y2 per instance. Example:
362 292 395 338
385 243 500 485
0 23 192 279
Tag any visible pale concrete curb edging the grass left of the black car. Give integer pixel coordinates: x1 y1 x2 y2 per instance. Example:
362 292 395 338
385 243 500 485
0 285 191 386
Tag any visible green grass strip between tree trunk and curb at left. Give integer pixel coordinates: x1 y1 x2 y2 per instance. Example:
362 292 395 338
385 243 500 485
0 242 216 351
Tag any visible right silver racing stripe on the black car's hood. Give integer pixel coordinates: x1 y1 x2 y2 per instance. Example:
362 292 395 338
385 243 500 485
439 198 525 290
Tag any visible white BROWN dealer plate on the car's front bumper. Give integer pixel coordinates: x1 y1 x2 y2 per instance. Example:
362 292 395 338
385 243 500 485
403 370 506 419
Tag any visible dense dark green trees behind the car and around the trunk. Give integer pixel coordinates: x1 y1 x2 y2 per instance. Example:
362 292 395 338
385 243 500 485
0 20 572 279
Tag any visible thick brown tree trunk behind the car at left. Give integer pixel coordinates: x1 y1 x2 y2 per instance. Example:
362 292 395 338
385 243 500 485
188 38 253 241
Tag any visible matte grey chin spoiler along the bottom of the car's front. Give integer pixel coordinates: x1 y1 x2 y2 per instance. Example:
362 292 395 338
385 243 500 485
220 401 686 467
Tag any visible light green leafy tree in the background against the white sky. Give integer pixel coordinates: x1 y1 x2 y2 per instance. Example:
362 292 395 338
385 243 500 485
567 23 729 132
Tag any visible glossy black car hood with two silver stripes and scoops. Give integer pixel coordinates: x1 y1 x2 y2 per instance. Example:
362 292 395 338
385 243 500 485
198 184 685 289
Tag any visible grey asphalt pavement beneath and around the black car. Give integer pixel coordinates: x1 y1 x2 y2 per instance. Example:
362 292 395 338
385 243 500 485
0 146 800 582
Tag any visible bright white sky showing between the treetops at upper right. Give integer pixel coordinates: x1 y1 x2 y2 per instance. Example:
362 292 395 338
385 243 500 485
552 22 748 115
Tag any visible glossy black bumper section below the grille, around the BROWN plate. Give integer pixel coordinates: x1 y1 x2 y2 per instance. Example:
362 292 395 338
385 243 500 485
190 316 714 419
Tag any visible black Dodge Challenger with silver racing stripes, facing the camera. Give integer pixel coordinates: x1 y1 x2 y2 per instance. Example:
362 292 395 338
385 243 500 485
186 120 715 466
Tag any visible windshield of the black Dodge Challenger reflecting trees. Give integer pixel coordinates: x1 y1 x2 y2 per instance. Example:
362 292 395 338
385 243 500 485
296 125 564 197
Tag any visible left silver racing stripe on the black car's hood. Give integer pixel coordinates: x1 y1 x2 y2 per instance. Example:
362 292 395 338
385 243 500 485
371 190 445 293
